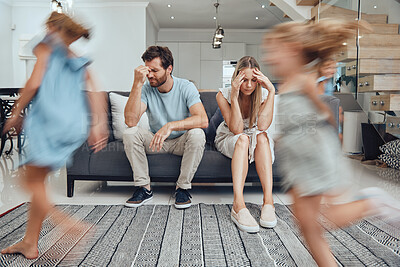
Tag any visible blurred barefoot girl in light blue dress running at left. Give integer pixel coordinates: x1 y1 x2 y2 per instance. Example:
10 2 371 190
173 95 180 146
1 12 108 259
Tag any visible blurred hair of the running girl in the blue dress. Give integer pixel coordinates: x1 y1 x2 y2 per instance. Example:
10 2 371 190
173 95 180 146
46 12 90 39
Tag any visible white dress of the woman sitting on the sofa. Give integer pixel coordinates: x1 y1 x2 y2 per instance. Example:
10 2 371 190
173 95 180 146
214 88 275 163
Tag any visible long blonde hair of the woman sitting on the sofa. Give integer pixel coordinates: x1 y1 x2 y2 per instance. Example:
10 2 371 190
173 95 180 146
232 56 262 127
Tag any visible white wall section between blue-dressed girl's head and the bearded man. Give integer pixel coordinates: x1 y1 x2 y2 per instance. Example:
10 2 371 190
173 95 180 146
72 3 147 91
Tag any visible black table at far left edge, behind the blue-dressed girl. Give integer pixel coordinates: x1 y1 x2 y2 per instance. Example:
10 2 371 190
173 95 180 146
0 88 25 155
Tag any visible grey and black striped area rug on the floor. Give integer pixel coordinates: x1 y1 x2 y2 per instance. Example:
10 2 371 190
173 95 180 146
0 204 400 267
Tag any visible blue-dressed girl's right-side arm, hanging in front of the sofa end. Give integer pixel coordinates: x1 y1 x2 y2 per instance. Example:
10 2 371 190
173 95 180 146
86 71 108 152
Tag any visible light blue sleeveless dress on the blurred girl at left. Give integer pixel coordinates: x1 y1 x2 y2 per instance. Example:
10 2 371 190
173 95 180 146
21 34 90 170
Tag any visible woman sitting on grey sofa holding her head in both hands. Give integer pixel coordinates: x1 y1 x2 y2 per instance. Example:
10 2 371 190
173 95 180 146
215 56 277 233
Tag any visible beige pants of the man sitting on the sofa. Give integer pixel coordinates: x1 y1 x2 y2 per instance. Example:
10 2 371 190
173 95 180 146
123 126 206 189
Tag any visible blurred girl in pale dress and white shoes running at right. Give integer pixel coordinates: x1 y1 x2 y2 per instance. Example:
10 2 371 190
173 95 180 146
264 20 400 266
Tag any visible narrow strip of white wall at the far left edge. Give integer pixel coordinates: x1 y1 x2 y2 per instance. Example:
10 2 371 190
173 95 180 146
0 1 14 88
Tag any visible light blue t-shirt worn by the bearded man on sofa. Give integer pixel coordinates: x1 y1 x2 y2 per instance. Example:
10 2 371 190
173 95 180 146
142 76 201 139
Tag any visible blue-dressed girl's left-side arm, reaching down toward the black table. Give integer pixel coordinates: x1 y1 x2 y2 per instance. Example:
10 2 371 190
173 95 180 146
3 44 51 132
